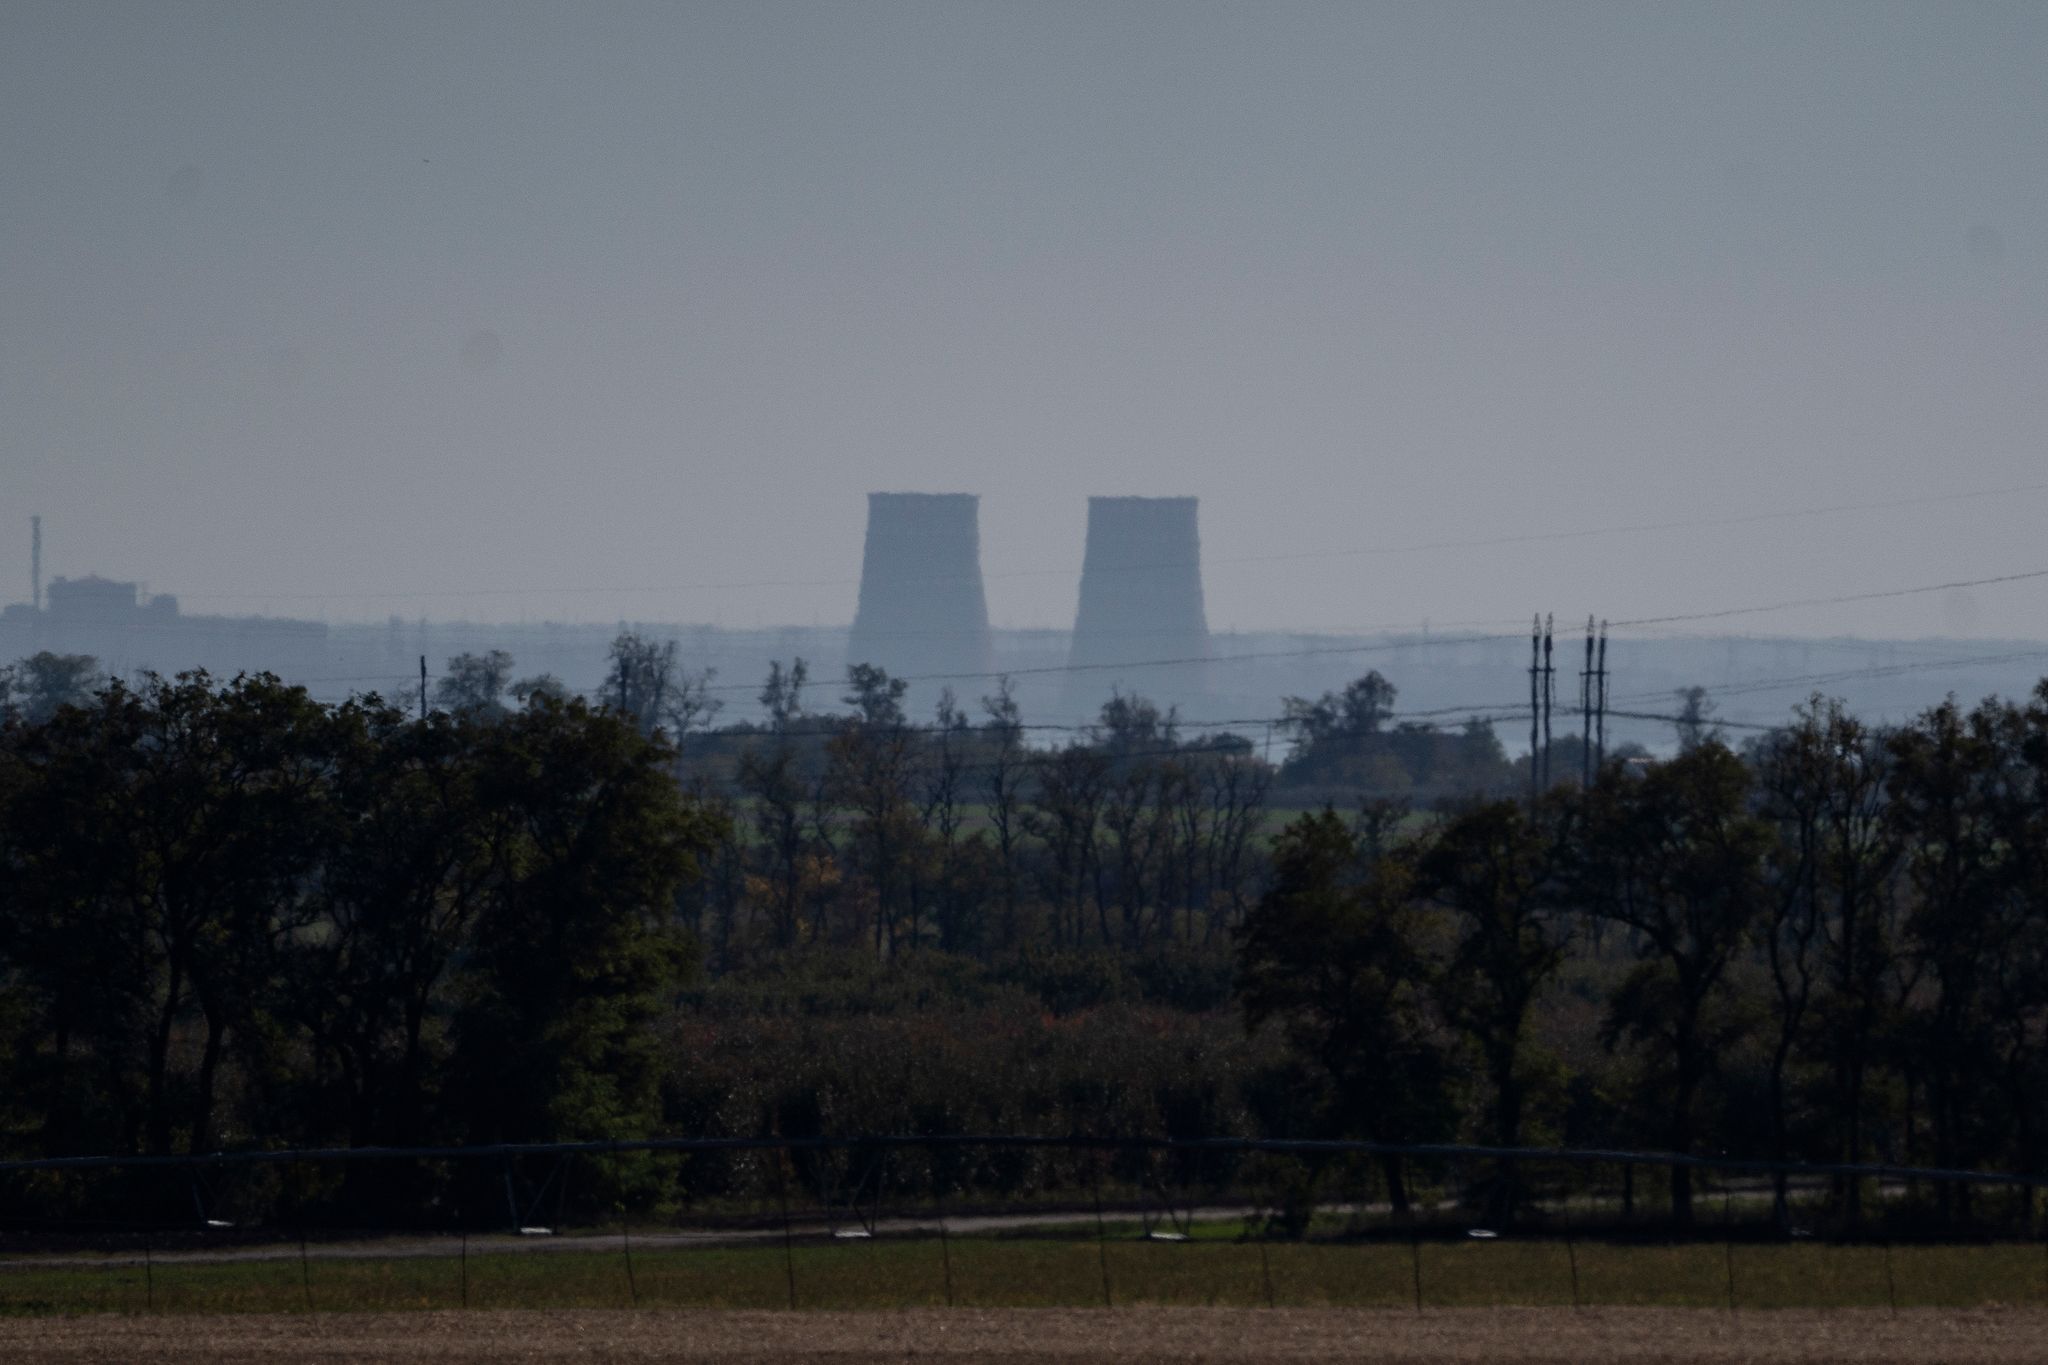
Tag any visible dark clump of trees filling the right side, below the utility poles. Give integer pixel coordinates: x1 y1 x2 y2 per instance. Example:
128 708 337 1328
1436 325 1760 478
1241 684 2048 1218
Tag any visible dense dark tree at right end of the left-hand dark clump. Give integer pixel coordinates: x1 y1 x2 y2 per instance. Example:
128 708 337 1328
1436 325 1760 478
453 702 717 1142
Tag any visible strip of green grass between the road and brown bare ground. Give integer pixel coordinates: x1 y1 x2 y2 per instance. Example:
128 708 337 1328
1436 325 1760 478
0 1236 2048 1316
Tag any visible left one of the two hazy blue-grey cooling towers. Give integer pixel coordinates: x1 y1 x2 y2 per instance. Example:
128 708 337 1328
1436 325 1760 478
848 493 989 696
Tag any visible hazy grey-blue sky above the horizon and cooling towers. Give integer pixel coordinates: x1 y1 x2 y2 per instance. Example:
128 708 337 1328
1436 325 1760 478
0 0 2048 636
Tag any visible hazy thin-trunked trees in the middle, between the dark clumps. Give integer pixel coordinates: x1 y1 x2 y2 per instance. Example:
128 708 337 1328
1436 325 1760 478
686 679 1272 972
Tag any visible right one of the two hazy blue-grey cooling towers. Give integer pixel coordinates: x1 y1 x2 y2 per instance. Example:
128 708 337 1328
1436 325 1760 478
1069 497 1208 687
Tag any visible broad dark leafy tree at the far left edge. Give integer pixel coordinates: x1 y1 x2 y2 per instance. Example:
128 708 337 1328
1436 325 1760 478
6 673 328 1152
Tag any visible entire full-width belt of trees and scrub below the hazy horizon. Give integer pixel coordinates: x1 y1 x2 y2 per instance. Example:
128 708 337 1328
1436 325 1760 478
0 634 2048 1218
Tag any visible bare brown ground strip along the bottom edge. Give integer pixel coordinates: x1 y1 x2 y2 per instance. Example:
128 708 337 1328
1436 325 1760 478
0 1308 2048 1365
